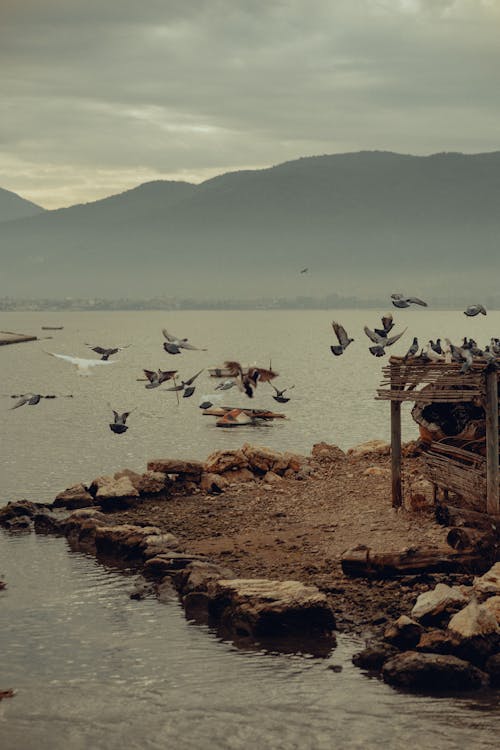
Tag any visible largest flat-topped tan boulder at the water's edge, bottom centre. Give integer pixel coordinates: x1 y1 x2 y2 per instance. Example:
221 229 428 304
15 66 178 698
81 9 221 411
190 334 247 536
208 578 335 637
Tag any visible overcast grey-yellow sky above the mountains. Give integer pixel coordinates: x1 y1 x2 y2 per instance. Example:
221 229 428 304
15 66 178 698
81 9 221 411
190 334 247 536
0 0 500 208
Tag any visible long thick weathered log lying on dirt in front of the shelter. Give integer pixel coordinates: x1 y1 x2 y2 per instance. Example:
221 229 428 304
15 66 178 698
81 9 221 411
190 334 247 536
341 547 491 578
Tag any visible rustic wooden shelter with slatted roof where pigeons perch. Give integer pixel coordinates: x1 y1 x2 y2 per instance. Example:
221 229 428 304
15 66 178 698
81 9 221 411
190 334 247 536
377 357 500 516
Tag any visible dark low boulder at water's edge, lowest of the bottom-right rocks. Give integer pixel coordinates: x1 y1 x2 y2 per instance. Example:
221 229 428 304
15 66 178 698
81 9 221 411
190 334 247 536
382 651 488 692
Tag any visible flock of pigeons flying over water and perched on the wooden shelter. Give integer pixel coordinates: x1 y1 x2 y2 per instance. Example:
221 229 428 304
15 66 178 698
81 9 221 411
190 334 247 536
6 296 500 434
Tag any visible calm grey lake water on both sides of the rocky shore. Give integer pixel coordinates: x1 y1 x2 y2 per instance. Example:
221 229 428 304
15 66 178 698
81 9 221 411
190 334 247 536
0 310 500 750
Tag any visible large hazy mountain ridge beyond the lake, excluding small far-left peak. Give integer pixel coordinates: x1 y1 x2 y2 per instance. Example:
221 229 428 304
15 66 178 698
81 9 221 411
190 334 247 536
0 152 500 299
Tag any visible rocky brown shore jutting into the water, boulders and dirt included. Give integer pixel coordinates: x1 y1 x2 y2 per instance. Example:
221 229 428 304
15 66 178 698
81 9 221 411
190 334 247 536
0 441 500 690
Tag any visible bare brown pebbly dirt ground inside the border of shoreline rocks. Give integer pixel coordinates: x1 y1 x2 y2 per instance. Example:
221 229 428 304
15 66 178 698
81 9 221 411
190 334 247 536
113 454 464 636
